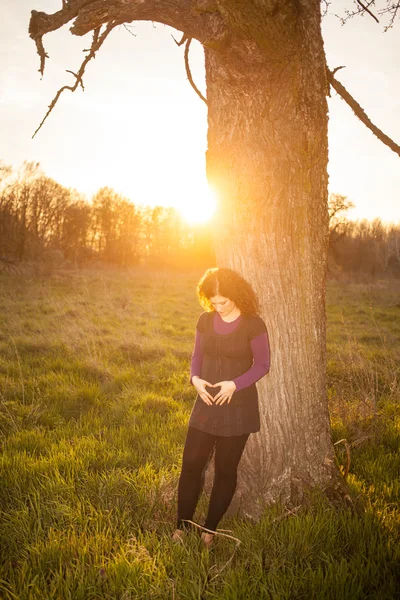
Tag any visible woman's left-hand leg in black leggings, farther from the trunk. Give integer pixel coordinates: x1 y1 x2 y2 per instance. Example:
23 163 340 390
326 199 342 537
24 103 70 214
177 427 216 529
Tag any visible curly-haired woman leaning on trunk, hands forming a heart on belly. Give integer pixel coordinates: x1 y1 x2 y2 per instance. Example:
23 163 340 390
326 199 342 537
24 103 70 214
173 268 270 546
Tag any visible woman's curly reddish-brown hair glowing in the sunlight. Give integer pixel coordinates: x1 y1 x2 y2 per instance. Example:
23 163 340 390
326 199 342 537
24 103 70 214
197 268 260 315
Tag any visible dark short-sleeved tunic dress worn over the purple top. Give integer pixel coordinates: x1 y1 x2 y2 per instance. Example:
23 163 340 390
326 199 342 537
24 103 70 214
189 312 267 436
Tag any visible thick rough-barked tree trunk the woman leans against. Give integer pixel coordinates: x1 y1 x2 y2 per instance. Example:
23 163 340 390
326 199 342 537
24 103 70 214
205 1 335 516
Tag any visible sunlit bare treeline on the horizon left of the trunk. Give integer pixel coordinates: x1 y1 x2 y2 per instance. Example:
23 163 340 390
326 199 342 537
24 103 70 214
0 162 215 269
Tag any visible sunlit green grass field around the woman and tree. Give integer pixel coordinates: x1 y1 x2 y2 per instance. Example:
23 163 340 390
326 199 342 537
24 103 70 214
0 271 400 600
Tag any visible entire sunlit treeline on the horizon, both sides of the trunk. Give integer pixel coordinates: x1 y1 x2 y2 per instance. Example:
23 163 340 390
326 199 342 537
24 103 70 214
0 163 400 277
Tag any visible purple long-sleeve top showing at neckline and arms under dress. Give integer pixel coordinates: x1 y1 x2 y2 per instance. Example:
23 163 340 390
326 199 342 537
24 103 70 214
190 313 270 391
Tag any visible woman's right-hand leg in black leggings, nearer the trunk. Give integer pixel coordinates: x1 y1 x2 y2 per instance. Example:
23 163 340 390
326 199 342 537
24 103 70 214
204 433 249 531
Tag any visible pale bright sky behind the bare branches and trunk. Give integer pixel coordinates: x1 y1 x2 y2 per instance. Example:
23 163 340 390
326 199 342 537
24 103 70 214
0 0 400 223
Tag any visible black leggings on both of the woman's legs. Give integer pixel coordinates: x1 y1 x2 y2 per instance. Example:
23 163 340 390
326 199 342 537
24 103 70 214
177 427 250 531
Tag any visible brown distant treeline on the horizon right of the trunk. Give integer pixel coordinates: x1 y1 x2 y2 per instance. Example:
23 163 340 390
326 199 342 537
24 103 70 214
328 194 400 277
